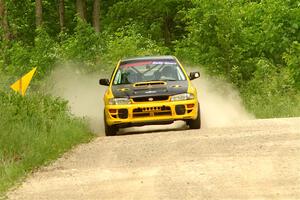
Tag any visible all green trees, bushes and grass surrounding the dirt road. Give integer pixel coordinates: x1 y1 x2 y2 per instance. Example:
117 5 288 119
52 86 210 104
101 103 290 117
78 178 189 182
0 0 300 194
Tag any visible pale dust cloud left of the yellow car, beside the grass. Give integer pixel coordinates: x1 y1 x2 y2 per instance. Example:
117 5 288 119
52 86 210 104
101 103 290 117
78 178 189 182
48 64 108 135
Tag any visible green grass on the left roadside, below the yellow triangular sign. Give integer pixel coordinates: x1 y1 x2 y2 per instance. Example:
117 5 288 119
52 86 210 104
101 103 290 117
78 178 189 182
0 92 92 197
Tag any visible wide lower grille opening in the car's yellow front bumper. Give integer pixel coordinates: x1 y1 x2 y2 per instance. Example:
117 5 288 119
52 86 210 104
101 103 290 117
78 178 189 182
132 106 172 118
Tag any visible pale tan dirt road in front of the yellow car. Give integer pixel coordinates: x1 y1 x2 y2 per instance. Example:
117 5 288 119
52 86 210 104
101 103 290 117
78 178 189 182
9 118 300 200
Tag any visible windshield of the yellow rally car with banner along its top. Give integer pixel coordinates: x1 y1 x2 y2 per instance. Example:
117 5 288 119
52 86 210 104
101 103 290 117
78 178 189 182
113 61 186 85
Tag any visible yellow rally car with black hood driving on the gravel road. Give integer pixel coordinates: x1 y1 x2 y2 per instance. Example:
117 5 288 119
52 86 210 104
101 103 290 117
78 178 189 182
99 56 201 136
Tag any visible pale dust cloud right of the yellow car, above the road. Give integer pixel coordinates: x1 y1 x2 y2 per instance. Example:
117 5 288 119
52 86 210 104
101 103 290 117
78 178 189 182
191 68 254 127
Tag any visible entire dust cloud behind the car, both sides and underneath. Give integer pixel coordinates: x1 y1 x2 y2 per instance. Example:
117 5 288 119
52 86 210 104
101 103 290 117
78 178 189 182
47 64 253 135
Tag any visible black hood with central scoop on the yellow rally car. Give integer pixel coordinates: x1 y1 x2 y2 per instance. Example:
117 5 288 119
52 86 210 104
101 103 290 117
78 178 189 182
112 81 188 98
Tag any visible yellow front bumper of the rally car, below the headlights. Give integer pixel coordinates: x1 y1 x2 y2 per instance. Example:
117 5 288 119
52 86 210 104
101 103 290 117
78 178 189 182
105 99 199 127
